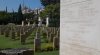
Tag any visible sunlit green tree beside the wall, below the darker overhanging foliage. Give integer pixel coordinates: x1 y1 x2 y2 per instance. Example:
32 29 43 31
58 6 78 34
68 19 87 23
40 3 60 27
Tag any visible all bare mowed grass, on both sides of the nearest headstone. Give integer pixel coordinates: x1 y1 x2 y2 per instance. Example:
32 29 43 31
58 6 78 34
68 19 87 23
0 35 59 55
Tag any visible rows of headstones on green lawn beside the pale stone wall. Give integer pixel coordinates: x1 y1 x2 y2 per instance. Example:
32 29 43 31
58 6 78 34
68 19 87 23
0 25 60 55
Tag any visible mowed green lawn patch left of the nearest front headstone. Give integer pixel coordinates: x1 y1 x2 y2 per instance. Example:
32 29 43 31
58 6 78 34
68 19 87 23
0 35 34 48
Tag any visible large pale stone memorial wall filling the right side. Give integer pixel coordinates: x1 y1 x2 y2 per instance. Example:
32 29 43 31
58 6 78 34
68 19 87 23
60 0 100 55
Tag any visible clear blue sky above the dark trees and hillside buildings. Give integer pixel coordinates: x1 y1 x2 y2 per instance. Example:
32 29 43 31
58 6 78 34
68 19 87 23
0 0 43 12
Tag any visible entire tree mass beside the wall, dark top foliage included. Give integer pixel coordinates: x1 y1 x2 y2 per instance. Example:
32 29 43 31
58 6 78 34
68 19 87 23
40 0 60 27
